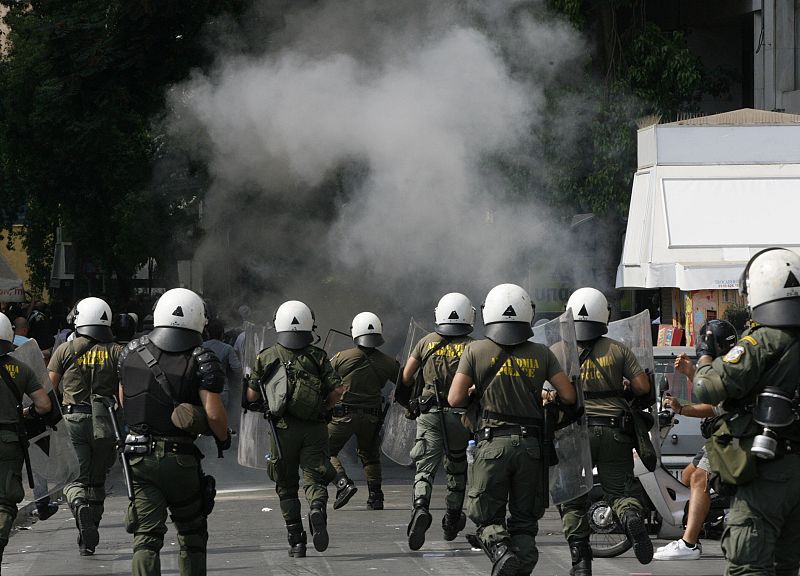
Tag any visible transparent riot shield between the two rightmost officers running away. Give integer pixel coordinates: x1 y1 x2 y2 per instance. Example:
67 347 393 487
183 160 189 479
531 310 593 504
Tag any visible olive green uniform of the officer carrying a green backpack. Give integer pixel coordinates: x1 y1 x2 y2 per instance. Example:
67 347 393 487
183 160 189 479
248 344 342 526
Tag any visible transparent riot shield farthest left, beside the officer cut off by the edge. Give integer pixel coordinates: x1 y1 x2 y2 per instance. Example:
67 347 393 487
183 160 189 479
11 340 80 501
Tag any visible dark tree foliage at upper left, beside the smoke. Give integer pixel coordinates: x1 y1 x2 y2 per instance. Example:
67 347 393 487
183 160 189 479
0 0 240 302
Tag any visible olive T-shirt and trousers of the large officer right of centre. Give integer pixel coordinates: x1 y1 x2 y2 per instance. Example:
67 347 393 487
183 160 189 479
458 340 562 574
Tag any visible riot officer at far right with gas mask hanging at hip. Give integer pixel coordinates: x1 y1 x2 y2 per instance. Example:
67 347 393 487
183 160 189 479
693 248 800 576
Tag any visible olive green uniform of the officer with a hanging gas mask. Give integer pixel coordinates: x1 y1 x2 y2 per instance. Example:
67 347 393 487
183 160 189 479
694 326 800 576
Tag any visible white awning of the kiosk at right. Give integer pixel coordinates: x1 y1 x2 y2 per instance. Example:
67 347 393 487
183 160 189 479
617 164 800 291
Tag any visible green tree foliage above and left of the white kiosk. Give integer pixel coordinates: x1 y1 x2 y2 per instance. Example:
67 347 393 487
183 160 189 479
544 0 727 217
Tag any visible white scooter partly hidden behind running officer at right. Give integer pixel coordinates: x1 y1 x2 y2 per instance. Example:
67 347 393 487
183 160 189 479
587 410 730 558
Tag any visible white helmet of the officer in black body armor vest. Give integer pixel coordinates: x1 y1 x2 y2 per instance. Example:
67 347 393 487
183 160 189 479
149 288 208 352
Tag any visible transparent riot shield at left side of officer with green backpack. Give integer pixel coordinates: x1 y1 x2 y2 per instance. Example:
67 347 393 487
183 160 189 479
236 322 277 470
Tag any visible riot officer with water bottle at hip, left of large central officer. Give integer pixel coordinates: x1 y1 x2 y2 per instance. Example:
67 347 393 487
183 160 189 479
403 292 475 550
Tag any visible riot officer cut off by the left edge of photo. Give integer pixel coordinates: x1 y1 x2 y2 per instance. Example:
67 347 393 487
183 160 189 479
0 313 53 561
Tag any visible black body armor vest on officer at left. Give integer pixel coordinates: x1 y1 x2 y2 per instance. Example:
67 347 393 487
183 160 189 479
120 340 201 436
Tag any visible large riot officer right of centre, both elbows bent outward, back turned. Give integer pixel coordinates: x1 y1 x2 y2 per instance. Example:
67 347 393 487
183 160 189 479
448 284 577 576
